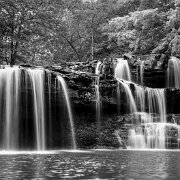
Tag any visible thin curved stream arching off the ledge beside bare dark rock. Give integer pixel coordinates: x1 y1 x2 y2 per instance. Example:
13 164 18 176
57 76 77 149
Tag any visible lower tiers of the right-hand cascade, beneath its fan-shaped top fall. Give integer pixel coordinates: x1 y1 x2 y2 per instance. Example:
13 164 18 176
128 87 166 149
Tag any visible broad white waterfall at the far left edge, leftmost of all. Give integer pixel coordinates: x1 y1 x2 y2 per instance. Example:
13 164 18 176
0 67 21 150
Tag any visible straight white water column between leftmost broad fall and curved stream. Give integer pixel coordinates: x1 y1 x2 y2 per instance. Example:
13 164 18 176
28 69 46 150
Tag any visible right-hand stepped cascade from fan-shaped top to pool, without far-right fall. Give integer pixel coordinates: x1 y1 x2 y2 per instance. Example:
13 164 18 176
115 59 166 149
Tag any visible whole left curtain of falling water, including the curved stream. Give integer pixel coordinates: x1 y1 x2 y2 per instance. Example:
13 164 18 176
0 66 76 151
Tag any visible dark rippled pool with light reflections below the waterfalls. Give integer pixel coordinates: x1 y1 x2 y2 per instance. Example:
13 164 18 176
0 151 180 180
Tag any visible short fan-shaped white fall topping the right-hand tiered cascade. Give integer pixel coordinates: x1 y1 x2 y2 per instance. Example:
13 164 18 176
114 58 131 81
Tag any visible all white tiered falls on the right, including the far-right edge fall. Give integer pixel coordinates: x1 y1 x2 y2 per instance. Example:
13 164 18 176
115 57 180 149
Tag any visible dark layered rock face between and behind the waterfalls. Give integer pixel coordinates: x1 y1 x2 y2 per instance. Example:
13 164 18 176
48 59 180 148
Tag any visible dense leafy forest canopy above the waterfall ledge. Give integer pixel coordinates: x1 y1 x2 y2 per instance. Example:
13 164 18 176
0 0 180 65
